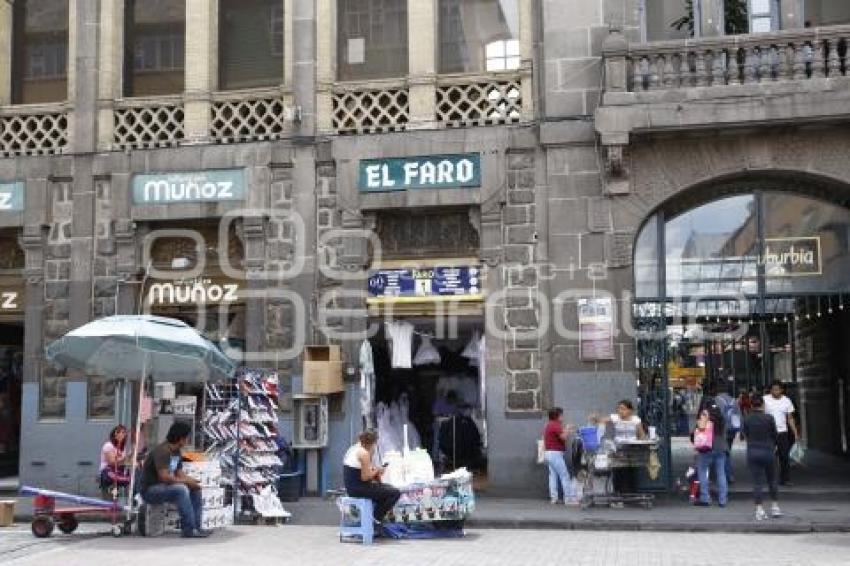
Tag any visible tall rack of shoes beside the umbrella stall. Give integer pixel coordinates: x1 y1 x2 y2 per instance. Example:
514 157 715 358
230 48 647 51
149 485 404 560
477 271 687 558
204 368 290 522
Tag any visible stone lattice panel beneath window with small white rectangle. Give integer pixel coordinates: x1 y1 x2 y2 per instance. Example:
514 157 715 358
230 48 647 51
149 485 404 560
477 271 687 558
333 89 410 134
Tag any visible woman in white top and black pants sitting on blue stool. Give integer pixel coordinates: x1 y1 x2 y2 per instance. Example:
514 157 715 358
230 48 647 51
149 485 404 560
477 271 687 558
343 430 401 523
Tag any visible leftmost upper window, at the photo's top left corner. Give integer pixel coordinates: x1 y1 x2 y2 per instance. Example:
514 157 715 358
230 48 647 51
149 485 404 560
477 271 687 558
12 0 68 104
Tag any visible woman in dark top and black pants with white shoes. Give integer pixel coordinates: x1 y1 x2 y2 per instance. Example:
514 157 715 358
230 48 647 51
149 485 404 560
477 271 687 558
741 396 782 521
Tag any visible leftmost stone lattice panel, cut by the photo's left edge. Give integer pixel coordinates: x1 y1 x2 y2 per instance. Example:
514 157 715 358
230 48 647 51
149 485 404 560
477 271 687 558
0 113 68 157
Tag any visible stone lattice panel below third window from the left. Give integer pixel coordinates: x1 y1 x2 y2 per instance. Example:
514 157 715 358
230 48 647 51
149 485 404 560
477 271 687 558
212 98 286 143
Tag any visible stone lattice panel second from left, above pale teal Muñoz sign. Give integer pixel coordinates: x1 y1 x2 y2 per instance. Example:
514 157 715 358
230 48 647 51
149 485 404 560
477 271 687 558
112 104 185 149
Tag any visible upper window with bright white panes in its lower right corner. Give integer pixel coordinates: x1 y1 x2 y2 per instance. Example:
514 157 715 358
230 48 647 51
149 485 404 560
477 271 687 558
439 0 520 73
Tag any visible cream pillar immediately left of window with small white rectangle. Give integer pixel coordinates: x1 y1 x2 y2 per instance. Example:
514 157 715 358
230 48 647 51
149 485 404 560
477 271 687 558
315 0 337 133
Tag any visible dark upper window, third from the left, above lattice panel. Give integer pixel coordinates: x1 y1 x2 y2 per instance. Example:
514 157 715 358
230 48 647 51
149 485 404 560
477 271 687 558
218 0 283 90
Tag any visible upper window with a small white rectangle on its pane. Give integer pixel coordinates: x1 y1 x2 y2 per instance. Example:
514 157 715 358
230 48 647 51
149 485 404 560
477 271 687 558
337 0 407 81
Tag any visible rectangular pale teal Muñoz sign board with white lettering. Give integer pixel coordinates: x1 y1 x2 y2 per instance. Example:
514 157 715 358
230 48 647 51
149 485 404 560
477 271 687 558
133 169 245 204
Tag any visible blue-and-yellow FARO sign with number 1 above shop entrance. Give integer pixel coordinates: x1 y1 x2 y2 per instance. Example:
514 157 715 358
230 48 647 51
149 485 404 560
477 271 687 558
369 266 482 297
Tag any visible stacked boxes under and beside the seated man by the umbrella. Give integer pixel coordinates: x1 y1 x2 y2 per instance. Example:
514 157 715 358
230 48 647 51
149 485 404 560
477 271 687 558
144 460 233 537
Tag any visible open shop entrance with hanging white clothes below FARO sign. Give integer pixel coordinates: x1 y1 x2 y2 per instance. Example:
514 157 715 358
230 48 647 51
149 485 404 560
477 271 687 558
362 315 487 486
